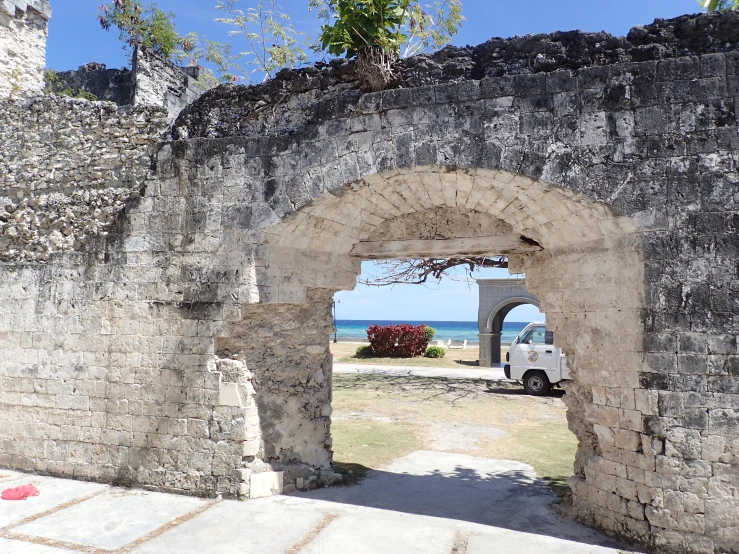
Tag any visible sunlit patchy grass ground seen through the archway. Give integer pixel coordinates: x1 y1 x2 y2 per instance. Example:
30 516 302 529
331 374 577 496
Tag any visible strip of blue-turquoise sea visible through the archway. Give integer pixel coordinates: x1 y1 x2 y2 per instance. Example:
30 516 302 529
336 319 529 345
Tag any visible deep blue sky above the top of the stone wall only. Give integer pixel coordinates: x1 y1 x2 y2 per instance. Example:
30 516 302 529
47 0 699 70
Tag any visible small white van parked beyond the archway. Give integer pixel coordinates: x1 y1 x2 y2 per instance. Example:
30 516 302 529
503 322 570 396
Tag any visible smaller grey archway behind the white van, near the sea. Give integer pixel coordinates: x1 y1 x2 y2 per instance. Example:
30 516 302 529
477 279 539 367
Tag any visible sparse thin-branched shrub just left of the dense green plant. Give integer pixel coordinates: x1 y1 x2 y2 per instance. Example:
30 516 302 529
216 0 308 80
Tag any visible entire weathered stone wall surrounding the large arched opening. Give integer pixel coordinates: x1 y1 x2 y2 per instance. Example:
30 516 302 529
0 9 739 553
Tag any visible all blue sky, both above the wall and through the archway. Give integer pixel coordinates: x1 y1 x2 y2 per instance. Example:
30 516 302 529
47 0 699 321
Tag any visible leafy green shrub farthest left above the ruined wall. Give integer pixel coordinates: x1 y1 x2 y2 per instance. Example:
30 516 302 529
98 0 182 58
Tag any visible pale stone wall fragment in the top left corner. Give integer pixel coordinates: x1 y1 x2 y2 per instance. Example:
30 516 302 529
0 0 51 99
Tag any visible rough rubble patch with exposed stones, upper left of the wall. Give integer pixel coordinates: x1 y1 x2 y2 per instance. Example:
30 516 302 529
0 95 167 262
